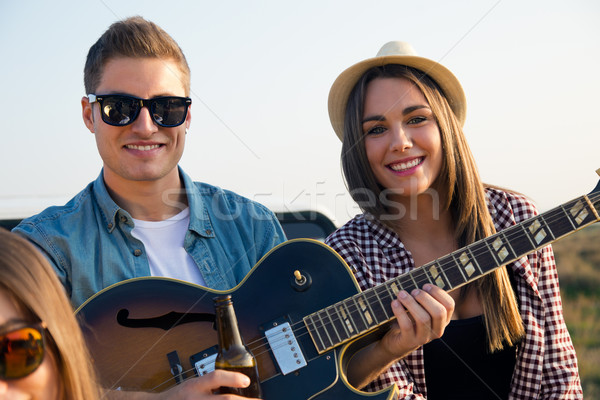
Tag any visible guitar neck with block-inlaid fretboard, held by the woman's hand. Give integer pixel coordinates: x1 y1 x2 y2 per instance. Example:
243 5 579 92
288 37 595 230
304 189 600 353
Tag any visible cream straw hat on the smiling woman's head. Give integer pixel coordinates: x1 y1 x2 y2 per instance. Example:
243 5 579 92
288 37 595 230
328 41 467 141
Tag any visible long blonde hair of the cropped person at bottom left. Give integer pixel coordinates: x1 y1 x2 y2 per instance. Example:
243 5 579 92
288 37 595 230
0 228 100 400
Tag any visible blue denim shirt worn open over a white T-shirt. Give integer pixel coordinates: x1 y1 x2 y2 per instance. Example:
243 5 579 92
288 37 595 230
13 168 285 308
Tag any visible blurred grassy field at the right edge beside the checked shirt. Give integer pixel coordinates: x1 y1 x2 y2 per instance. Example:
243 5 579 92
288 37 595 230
553 224 600 399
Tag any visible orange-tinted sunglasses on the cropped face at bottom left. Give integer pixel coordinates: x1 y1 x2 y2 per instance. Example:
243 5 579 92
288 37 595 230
0 322 46 380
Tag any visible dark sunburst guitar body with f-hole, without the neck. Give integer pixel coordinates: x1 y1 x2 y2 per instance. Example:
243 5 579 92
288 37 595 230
77 239 397 400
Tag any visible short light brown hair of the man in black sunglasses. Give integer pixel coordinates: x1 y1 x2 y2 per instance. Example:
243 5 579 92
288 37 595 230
83 16 190 96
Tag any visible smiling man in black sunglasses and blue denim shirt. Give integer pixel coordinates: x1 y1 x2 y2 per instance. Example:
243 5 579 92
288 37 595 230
14 17 285 398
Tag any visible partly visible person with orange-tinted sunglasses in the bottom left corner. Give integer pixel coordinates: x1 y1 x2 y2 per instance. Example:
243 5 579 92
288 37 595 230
0 228 99 400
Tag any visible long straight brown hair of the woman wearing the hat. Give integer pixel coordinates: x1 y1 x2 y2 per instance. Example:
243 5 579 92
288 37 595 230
342 64 524 351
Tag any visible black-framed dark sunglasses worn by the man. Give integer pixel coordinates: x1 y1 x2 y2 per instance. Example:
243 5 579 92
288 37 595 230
87 94 192 128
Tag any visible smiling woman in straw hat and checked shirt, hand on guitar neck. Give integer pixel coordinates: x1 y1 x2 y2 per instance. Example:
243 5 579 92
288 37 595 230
326 42 582 400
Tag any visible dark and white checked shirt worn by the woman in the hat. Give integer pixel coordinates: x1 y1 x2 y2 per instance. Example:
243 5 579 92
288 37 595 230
326 189 583 399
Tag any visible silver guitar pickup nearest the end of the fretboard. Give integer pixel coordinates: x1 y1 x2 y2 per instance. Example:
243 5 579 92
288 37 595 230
265 322 306 375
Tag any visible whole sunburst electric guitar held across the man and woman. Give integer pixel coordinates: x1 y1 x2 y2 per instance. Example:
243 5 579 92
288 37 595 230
77 173 600 400
